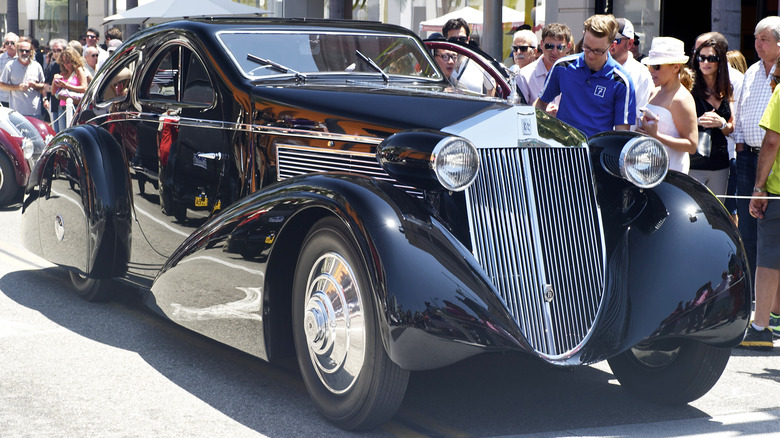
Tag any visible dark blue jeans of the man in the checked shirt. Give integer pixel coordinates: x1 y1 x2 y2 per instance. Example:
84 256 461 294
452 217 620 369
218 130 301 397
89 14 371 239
737 151 758 290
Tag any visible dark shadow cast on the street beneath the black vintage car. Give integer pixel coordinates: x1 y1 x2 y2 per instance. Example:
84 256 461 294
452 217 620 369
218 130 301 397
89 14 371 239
0 268 706 437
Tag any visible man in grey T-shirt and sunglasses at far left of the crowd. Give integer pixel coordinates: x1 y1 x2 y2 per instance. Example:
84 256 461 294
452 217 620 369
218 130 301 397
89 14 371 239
0 37 44 119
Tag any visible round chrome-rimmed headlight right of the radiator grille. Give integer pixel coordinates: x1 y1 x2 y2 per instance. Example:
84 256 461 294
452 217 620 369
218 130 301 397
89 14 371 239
620 136 669 189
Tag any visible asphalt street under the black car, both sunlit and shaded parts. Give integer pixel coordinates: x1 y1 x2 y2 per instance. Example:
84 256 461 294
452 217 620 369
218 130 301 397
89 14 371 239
0 206 780 438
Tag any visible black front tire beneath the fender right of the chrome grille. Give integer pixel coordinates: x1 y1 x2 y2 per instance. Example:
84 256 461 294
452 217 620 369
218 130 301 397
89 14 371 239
608 339 731 405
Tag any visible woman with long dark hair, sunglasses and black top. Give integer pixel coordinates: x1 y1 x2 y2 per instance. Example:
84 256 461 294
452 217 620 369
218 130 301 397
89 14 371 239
690 38 734 195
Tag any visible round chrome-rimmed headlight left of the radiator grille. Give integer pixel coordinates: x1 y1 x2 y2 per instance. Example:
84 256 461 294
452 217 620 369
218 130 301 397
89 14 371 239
431 137 479 192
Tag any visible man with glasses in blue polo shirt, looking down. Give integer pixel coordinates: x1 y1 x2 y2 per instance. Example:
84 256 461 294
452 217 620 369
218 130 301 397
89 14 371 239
534 15 636 137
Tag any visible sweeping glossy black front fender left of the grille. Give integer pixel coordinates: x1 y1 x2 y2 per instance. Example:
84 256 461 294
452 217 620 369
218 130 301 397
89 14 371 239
152 174 528 369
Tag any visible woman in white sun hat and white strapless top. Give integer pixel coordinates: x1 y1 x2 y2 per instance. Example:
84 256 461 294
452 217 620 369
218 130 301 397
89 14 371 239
637 37 699 173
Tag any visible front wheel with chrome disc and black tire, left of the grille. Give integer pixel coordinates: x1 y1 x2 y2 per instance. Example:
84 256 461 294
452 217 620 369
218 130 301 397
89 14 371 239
292 218 409 430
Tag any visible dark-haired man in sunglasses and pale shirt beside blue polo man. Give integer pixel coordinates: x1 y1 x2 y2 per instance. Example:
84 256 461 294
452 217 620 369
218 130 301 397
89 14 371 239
516 23 571 115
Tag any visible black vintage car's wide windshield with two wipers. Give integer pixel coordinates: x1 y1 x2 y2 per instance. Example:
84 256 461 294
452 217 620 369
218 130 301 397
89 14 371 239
218 31 440 79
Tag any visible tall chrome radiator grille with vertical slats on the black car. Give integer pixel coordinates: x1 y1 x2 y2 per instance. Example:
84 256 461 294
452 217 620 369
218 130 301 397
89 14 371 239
466 147 605 358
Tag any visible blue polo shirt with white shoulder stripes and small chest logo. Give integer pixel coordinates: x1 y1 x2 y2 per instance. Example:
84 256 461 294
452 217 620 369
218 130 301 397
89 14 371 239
539 53 636 137
